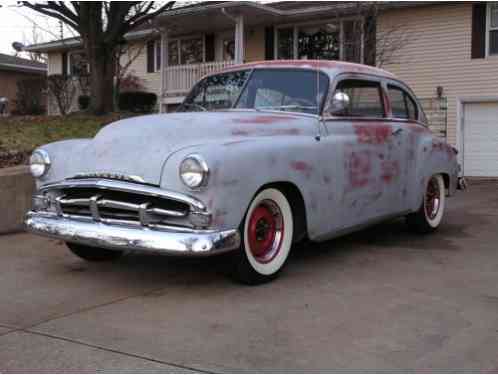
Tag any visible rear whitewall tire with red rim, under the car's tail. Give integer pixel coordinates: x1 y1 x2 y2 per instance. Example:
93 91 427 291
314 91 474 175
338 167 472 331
407 174 446 233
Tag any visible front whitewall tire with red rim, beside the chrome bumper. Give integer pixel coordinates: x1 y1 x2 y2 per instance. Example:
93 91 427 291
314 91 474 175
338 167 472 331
234 188 294 285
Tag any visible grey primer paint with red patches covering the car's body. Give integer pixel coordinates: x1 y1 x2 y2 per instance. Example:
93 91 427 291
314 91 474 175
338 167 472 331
34 63 458 240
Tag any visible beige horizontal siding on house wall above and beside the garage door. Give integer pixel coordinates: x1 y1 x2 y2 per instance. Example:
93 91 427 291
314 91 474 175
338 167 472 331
377 3 498 144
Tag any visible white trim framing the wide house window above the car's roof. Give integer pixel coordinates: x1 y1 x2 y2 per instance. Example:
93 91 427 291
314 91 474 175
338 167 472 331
273 16 365 64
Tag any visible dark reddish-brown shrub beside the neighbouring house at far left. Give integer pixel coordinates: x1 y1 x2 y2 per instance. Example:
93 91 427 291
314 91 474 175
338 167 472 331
14 77 46 116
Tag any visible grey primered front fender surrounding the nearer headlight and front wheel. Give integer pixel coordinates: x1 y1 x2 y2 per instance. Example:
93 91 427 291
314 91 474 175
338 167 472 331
161 136 322 234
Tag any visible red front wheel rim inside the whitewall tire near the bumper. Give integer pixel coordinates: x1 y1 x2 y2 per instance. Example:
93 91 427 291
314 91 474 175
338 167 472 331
247 199 284 263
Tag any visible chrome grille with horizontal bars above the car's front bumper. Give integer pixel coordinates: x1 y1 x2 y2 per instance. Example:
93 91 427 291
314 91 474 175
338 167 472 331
35 179 210 227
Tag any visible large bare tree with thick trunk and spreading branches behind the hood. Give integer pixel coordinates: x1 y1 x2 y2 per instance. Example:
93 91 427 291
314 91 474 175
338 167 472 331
22 1 174 114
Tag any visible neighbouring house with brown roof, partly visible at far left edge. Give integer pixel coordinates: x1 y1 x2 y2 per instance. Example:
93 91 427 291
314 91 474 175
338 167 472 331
0 54 47 113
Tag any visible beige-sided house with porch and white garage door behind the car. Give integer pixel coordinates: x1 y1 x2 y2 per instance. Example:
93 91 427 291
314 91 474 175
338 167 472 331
28 1 498 177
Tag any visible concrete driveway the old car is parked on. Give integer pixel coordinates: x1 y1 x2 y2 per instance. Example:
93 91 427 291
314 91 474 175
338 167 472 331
0 183 498 372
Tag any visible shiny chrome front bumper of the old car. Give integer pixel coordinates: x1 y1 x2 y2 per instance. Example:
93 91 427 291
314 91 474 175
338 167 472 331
24 211 240 255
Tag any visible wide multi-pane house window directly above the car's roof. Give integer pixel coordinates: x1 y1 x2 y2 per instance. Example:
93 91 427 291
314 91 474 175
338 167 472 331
275 20 363 62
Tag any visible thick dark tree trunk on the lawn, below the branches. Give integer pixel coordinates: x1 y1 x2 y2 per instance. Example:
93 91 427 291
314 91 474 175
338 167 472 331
88 43 115 115
